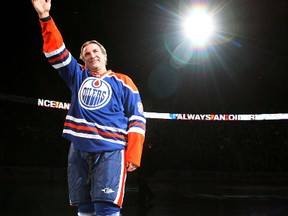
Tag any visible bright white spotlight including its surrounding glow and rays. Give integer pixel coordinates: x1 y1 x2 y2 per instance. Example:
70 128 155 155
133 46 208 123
158 0 241 69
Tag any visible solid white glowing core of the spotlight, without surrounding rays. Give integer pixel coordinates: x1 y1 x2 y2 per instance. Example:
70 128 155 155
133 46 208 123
183 6 214 48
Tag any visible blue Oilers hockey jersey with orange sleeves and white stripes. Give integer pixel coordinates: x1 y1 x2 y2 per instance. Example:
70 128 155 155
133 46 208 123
40 17 146 166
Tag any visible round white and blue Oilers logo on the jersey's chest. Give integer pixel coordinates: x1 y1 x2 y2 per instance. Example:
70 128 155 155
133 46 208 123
78 77 112 110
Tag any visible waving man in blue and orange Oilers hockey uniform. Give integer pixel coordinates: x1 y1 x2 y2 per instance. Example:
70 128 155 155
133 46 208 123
32 0 146 216
